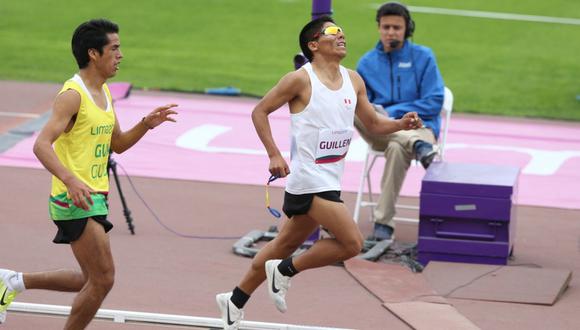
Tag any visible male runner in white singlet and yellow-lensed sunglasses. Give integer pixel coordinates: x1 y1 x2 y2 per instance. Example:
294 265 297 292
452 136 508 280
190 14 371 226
216 16 421 329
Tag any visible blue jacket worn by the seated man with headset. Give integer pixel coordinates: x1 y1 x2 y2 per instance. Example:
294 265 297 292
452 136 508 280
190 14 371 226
357 40 445 137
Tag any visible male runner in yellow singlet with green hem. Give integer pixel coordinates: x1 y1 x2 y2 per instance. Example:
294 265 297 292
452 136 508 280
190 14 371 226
0 19 176 329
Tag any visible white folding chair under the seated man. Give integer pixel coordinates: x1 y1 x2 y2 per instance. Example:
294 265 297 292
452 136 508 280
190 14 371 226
353 87 453 223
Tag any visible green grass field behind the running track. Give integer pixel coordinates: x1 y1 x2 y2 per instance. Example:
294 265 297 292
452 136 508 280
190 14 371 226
0 0 580 121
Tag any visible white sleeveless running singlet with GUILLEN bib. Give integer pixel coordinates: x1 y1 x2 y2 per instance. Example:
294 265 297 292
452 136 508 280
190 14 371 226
286 63 357 195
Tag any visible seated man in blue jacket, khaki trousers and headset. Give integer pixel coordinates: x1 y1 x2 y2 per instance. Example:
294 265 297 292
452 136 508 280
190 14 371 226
355 2 444 240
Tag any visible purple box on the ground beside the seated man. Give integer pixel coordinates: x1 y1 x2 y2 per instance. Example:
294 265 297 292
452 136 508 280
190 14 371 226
418 162 520 265
